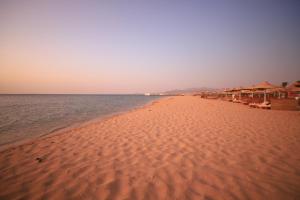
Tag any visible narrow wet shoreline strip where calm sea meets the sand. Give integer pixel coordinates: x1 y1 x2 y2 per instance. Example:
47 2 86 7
0 96 165 153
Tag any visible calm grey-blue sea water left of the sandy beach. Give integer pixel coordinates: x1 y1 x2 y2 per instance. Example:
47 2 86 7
0 95 159 145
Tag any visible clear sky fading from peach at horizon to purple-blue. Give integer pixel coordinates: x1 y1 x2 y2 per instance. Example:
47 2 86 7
0 0 300 94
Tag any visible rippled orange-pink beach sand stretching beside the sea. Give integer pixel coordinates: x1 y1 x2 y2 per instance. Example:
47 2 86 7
0 96 300 200
